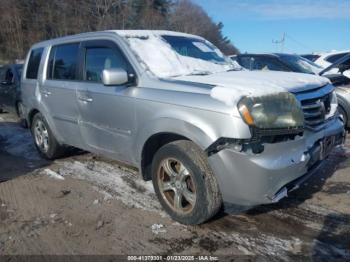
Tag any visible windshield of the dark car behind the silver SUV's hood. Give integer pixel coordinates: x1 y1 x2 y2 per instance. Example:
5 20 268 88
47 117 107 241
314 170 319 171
280 55 323 74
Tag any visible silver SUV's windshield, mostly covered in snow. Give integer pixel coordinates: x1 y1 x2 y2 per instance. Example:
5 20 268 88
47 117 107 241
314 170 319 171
123 35 235 77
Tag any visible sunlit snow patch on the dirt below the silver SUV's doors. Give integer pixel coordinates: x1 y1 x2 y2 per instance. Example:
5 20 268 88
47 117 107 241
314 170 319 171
57 161 166 216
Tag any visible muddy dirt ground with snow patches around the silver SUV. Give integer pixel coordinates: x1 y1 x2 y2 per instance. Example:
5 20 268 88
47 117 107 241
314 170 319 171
0 110 350 260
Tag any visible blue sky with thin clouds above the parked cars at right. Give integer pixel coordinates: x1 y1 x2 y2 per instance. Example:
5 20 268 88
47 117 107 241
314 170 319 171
194 0 350 53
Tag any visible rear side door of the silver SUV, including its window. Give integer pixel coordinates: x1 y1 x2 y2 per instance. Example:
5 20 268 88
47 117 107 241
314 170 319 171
40 42 82 147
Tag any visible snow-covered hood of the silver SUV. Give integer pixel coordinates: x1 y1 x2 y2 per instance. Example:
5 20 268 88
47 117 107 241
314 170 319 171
175 71 330 106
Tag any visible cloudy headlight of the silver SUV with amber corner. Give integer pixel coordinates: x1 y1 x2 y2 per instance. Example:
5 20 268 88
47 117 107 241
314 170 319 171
238 92 304 129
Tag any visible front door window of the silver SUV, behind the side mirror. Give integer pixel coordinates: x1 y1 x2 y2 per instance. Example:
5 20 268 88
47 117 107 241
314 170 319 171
84 47 128 82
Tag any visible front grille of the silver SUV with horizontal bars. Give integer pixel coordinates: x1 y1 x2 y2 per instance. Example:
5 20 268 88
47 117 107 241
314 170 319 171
295 85 333 129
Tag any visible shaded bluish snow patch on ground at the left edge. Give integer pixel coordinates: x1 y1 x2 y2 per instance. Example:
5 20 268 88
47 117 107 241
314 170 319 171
0 119 41 160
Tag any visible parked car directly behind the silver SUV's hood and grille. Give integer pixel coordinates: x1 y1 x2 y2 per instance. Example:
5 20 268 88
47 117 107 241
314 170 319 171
234 53 350 129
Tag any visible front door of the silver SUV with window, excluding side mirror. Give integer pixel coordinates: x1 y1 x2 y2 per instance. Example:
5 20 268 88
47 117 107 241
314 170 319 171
77 40 135 162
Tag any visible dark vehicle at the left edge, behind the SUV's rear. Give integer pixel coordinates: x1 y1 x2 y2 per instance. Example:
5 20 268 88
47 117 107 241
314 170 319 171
0 64 24 124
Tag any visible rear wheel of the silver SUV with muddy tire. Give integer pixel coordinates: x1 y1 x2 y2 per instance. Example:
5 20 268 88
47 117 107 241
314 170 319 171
31 113 65 160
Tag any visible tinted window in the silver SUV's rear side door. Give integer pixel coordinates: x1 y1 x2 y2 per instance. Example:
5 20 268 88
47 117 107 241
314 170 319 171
47 43 79 80
